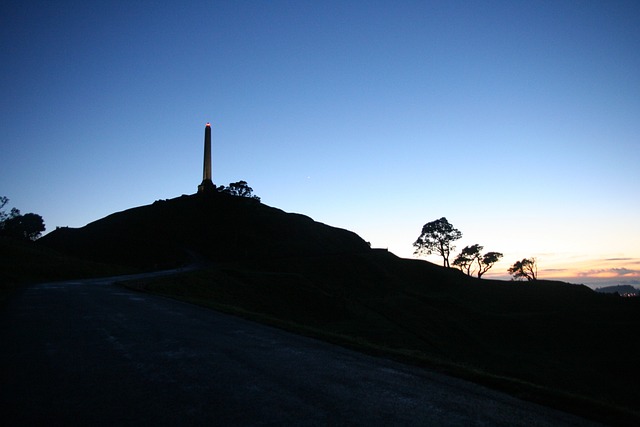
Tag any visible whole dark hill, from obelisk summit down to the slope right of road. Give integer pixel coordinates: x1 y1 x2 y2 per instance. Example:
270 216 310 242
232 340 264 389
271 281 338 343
37 193 640 424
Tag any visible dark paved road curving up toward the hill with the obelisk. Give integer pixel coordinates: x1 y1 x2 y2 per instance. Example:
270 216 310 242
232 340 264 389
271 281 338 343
0 280 604 427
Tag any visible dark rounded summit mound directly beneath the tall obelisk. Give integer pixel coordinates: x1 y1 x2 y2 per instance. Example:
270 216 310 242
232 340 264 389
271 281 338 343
38 193 370 268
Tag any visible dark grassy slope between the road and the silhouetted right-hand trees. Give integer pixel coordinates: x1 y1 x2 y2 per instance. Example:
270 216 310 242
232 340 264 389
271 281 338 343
128 251 640 425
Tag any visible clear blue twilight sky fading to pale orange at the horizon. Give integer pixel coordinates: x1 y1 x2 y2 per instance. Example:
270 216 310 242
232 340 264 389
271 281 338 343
0 0 640 286
